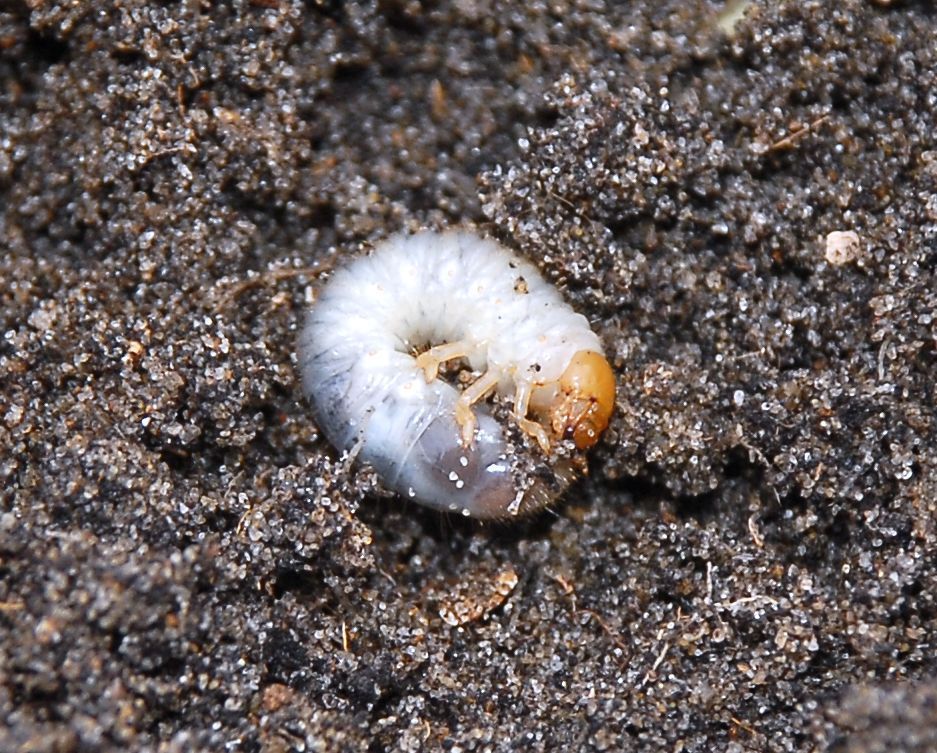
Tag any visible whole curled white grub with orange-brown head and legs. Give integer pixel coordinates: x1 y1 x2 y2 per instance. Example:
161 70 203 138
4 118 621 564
298 231 615 519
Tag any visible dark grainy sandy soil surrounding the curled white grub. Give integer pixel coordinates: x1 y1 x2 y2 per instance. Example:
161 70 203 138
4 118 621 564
0 0 937 753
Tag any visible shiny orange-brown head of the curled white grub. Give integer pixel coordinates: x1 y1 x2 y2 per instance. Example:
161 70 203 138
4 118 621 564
550 350 615 450
